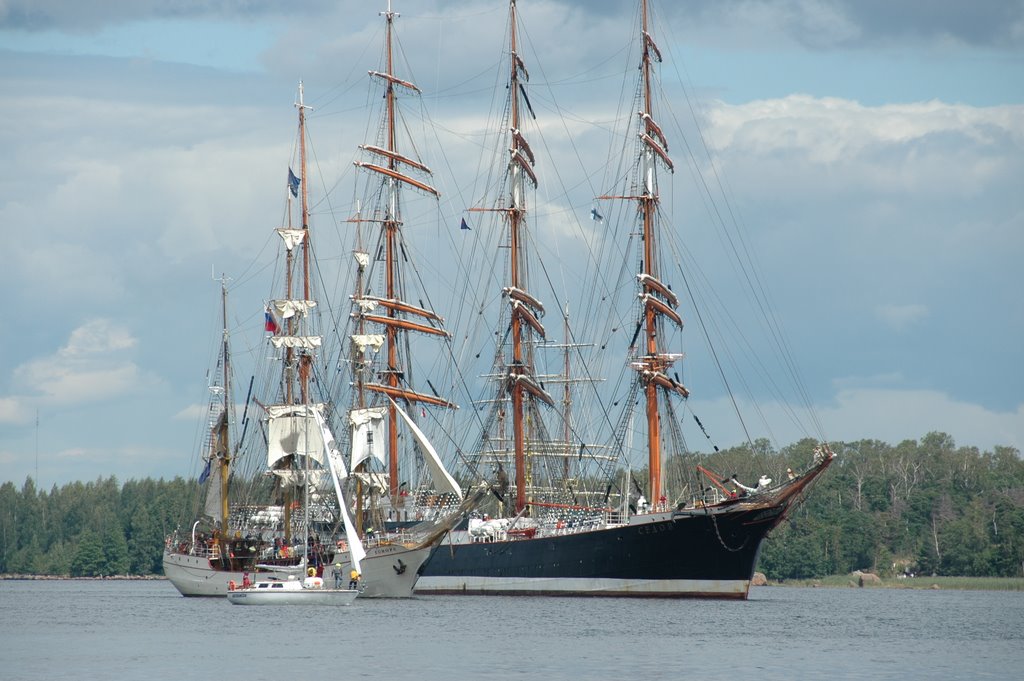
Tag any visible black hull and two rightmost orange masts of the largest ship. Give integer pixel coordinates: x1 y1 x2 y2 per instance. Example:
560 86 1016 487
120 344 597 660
417 0 834 599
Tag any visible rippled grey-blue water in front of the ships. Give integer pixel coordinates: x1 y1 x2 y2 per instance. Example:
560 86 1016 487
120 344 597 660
0 581 1024 681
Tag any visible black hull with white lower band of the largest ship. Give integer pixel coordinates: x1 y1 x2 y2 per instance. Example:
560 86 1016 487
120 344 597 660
417 504 786 598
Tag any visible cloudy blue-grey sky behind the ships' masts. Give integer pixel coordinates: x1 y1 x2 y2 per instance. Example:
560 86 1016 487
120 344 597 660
0 0 1024 488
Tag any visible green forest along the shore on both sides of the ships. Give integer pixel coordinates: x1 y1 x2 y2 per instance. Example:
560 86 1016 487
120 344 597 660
0 432 1024 580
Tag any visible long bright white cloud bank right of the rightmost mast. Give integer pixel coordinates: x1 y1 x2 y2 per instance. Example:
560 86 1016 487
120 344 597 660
709 94 1024 192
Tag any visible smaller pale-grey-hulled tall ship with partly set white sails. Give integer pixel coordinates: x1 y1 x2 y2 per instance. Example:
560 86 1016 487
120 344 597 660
163 73 474 598
